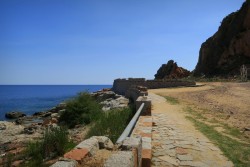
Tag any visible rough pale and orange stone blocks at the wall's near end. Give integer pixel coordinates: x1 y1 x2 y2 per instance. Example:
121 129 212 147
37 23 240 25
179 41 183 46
50 136 143 167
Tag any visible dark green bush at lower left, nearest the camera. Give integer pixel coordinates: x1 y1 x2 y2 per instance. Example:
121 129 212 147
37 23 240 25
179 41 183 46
26 127 75 166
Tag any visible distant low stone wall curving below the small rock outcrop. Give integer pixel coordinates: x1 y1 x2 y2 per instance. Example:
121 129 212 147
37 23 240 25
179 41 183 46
112 78 195 95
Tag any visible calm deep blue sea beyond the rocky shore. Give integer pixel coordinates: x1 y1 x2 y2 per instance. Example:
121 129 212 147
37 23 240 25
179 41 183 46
0 85 112 120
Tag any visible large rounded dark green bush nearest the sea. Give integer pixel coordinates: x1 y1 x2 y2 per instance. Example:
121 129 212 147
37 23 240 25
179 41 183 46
59 92 101 128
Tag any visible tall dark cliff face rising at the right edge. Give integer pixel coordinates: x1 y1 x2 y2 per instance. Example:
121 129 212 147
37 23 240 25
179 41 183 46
194 0 250 76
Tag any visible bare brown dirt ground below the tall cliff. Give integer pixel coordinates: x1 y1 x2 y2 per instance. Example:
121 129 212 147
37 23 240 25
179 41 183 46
149 82 250 137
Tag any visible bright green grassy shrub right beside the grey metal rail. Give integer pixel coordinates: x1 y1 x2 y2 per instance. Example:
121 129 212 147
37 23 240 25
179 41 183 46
87 108 133 142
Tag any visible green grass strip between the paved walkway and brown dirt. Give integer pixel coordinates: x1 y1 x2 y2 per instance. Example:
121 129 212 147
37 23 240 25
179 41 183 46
185 107 250 167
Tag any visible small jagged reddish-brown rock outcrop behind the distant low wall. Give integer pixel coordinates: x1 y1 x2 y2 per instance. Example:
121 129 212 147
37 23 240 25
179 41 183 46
155 60 190 79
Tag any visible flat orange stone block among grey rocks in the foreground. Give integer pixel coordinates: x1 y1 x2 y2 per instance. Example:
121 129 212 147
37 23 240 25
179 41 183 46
63 148 89 162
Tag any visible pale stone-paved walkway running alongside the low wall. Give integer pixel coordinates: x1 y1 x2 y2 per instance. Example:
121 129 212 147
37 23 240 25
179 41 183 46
149 93 233 167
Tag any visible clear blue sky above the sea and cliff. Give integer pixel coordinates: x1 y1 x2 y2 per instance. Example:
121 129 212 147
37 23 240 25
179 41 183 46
0 0 244 85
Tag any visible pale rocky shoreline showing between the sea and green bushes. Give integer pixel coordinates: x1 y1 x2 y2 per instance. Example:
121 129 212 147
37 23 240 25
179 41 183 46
0 89 129 166
